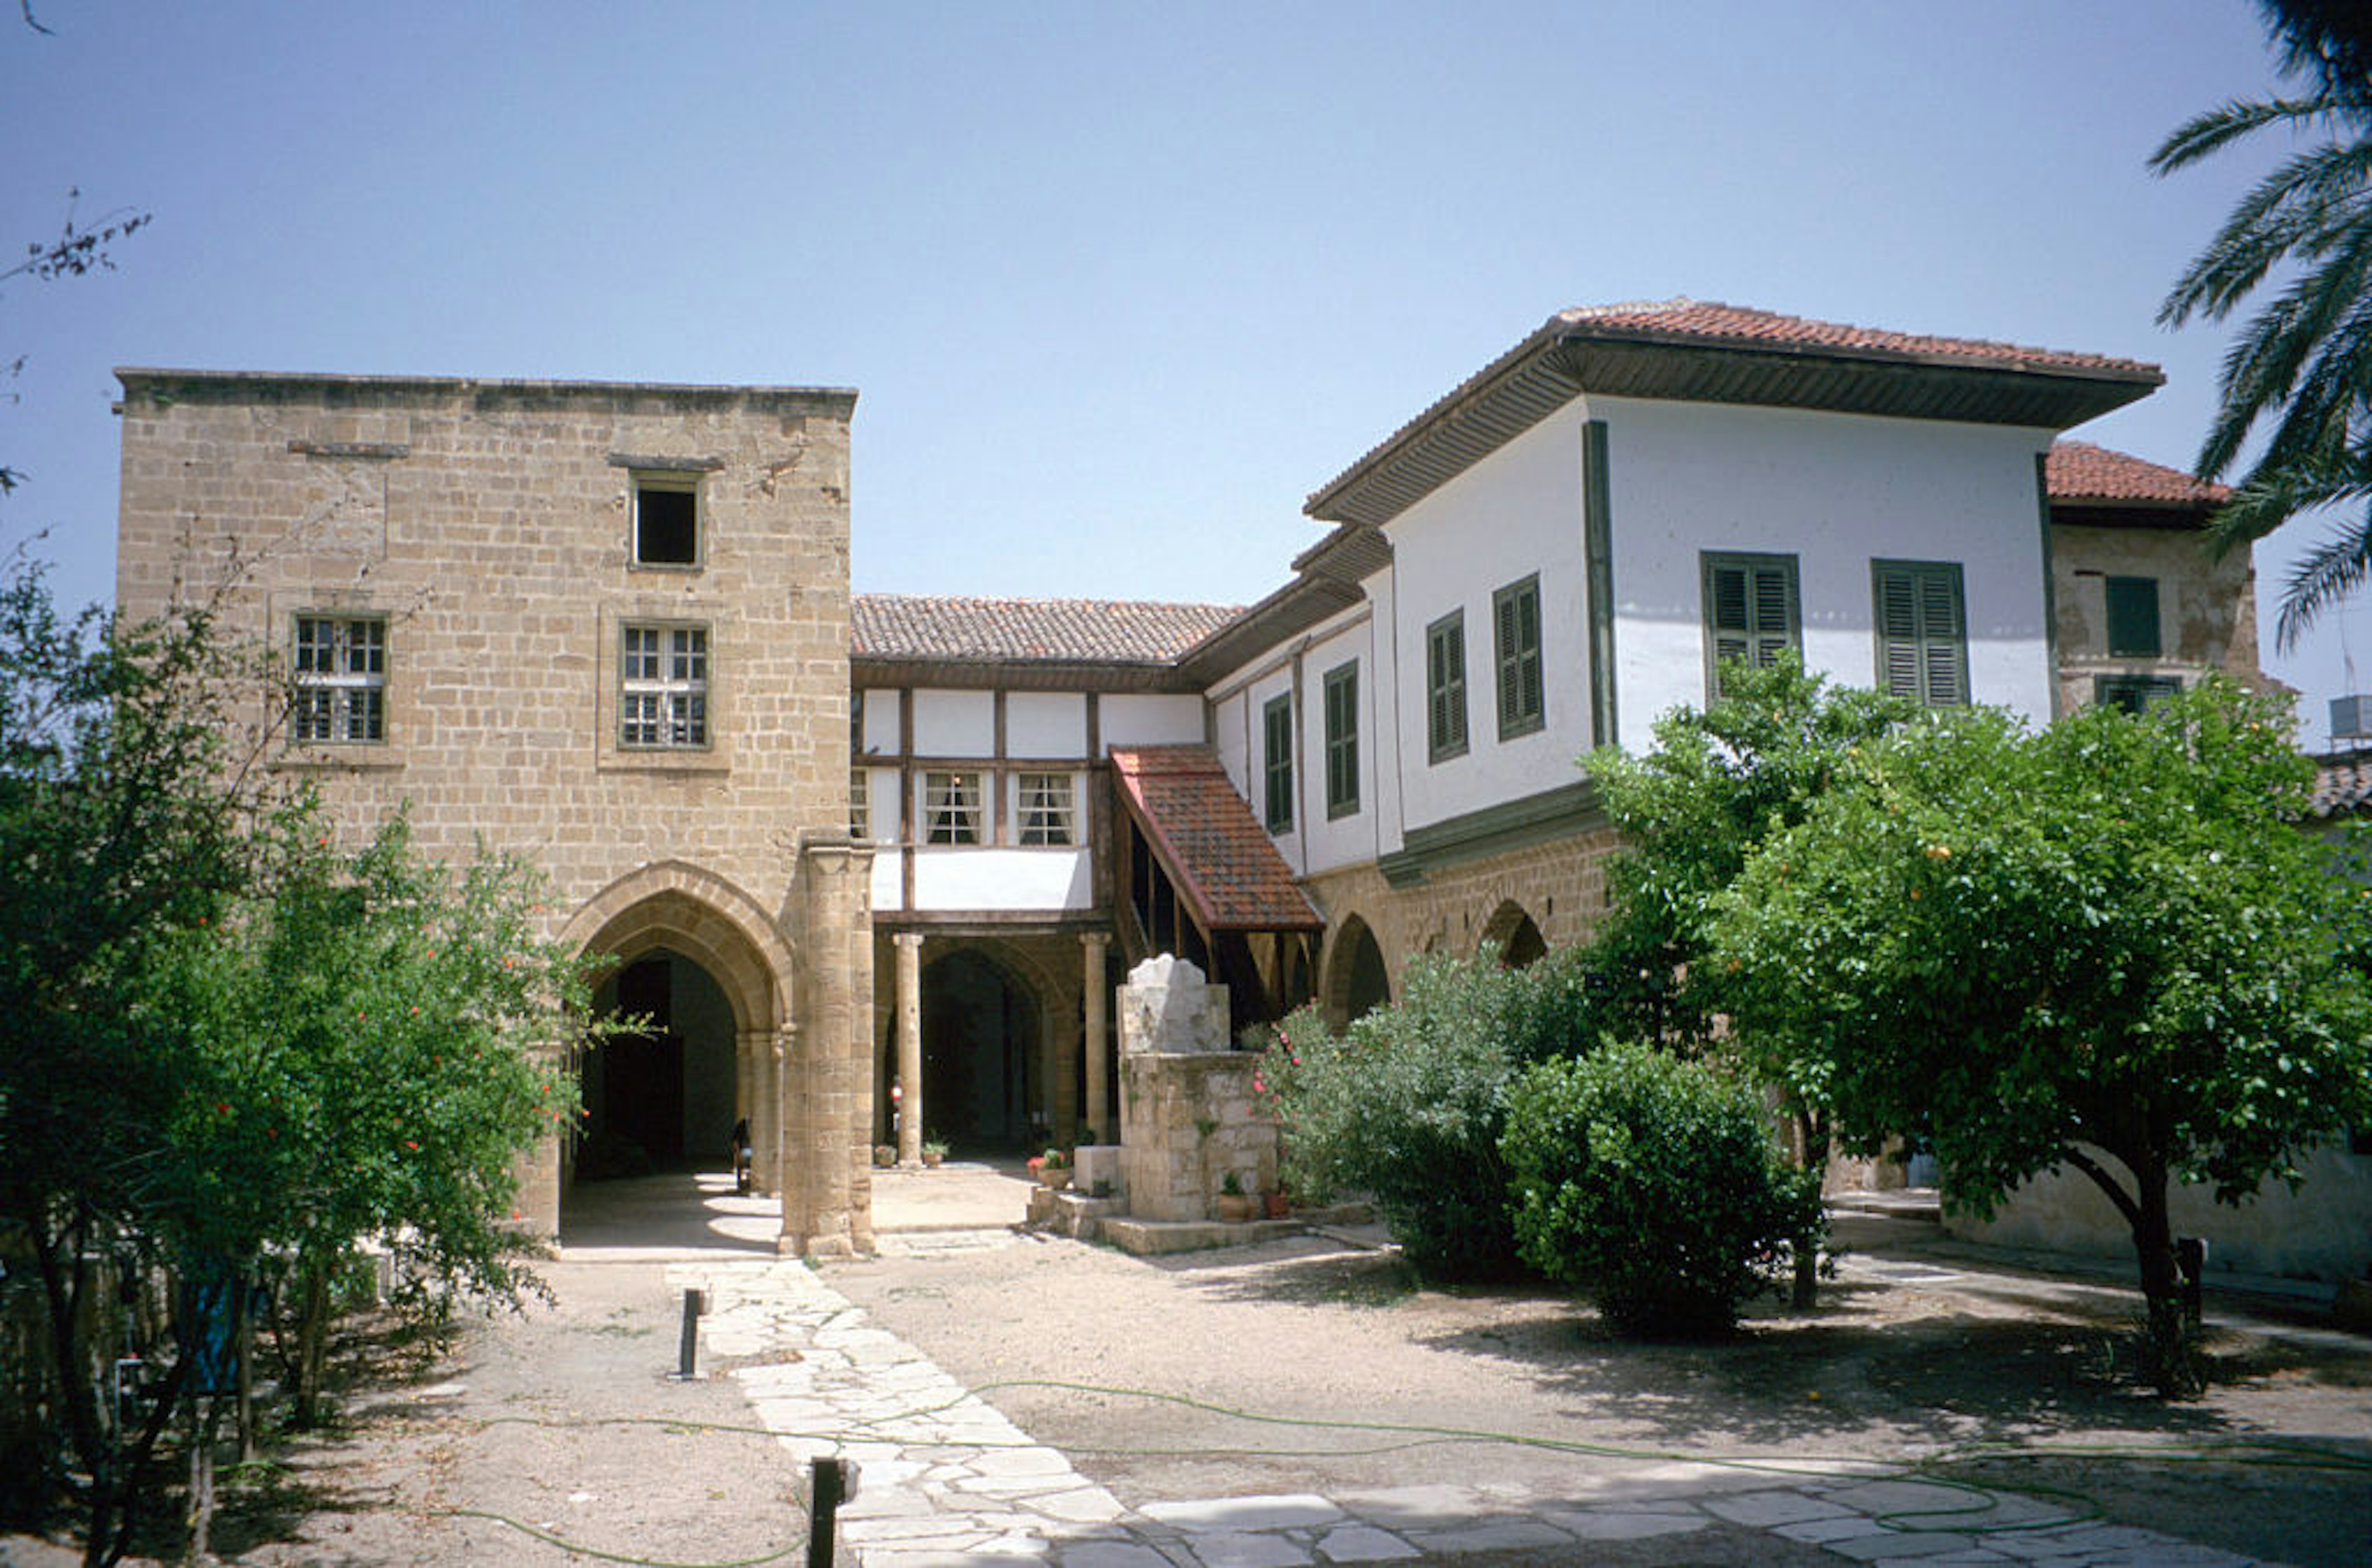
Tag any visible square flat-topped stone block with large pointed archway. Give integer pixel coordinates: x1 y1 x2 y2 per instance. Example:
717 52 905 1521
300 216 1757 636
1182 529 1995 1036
119 370 873 1252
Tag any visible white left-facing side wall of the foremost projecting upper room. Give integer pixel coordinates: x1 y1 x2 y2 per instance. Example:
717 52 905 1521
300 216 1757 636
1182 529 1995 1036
1386 403 1594 830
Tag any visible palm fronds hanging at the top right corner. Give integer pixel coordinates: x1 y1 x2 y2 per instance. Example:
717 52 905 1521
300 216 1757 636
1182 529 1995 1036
2149 0 2372 645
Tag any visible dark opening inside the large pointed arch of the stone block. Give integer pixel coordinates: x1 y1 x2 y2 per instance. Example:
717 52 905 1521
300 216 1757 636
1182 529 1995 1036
576 947 742 1181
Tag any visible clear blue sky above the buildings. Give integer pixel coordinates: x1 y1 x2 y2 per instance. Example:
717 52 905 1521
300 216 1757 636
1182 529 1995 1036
0 0 2372 726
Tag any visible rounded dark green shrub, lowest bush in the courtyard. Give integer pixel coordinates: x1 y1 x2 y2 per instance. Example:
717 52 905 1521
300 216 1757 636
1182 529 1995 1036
1502 1046 1822 1338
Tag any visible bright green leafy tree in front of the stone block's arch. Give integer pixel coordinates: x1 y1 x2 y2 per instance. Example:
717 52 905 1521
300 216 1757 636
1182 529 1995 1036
140 809 602 1421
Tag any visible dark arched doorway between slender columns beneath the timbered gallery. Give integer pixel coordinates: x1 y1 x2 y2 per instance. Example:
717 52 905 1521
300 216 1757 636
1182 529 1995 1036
923 949 1046 1151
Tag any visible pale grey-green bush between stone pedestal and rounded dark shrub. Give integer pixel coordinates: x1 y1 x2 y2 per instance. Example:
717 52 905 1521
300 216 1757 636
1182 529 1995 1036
1255 954 1596 1278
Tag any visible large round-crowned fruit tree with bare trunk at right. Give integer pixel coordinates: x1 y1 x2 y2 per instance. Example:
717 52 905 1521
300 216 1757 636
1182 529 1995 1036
1705 681 2372 1393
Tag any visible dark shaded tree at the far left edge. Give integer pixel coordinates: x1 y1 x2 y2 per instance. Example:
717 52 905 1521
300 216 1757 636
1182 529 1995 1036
0 555 256 1559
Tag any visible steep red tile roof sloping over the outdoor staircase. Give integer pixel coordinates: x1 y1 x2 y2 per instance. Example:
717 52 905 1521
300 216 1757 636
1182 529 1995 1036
1112 745 1326 933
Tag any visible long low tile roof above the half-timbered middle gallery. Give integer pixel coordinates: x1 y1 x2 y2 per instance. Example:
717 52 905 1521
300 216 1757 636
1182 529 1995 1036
849 593 1238 665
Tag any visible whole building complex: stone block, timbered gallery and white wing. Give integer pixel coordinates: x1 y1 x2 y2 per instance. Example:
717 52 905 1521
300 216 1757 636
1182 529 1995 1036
121 301 2315 1250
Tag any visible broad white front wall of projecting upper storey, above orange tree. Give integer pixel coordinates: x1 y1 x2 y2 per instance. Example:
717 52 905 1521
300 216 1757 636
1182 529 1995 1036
1613 398 2052 750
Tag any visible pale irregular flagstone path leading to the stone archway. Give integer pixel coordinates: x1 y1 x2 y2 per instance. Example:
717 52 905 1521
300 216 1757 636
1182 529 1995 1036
667 1236 2286 1568
